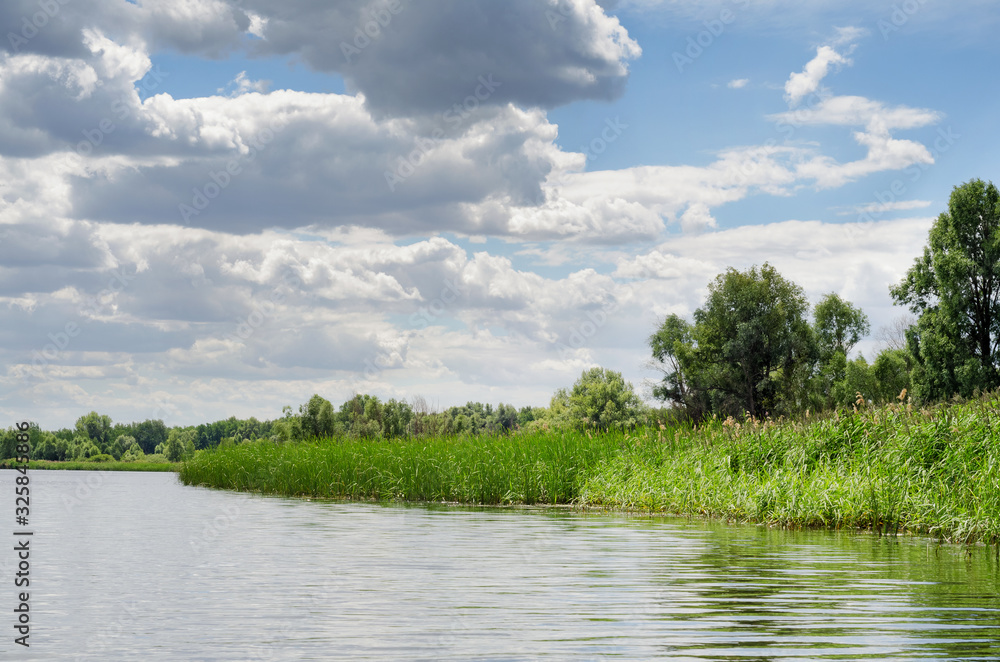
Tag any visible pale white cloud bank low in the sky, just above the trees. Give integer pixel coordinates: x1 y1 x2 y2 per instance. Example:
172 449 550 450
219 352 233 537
0 218 932 424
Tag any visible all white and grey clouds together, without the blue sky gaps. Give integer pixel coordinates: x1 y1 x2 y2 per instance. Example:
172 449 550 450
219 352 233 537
0 0 960 424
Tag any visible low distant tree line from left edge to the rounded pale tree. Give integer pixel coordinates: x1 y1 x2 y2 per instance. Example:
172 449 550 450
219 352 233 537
0 368 644 462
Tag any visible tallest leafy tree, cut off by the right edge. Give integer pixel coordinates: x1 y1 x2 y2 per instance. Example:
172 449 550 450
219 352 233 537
890 179 1000 399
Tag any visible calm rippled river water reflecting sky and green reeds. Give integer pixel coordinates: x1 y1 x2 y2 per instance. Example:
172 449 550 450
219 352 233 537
0 471 1000 662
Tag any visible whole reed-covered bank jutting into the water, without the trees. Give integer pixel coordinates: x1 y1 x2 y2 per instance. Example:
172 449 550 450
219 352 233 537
180 394 1000 543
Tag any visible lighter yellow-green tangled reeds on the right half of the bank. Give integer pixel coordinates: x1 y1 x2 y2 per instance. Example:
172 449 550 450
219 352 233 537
577 395 1000 543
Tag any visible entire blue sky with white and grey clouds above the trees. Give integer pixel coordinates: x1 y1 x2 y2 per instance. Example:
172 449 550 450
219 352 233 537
0 0 1000 429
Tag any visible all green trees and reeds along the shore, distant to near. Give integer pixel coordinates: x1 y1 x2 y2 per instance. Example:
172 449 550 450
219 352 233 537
9 179 1000 543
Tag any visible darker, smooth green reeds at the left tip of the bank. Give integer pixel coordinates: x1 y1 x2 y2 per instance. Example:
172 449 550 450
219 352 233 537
180 433 624 505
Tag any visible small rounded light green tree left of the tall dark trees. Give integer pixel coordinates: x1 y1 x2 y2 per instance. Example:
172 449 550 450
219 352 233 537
568 368 642 430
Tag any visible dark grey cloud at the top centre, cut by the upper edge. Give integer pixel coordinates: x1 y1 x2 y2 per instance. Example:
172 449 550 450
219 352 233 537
241 0 641 116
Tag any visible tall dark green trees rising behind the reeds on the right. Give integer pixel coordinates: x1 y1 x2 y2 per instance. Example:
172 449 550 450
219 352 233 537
649 179 1000 419
